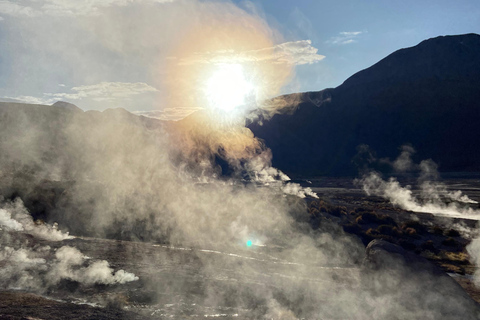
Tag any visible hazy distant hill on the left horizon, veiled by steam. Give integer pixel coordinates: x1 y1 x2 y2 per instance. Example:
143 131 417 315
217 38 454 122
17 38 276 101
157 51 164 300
0 102 161 173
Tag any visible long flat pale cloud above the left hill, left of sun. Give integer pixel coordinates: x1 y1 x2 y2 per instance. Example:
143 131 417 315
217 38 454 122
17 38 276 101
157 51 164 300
45 82 157 101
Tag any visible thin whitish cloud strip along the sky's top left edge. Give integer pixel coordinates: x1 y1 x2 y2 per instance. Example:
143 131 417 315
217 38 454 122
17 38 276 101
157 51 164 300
0 0 174 17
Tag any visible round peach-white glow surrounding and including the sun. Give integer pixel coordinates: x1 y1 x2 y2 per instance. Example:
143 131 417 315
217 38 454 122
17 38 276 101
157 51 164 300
165 8 293 122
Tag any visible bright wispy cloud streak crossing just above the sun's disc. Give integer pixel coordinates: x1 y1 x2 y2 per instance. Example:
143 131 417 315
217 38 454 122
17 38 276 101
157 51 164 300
179 40 325 65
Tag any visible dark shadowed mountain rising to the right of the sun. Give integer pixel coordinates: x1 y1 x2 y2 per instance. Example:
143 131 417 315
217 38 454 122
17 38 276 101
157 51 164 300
249 34 480 176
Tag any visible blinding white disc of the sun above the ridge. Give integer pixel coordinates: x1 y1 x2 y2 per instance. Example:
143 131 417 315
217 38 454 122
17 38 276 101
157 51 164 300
206 64 253 111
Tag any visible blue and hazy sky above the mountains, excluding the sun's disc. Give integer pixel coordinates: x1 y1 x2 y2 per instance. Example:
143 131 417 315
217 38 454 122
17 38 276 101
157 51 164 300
0 0 480 120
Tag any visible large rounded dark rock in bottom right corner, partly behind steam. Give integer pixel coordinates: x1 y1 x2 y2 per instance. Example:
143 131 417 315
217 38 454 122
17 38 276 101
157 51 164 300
364 239 480 320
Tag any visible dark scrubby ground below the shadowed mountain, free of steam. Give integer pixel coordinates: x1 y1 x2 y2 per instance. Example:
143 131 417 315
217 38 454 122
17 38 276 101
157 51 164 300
302 174 480 303
